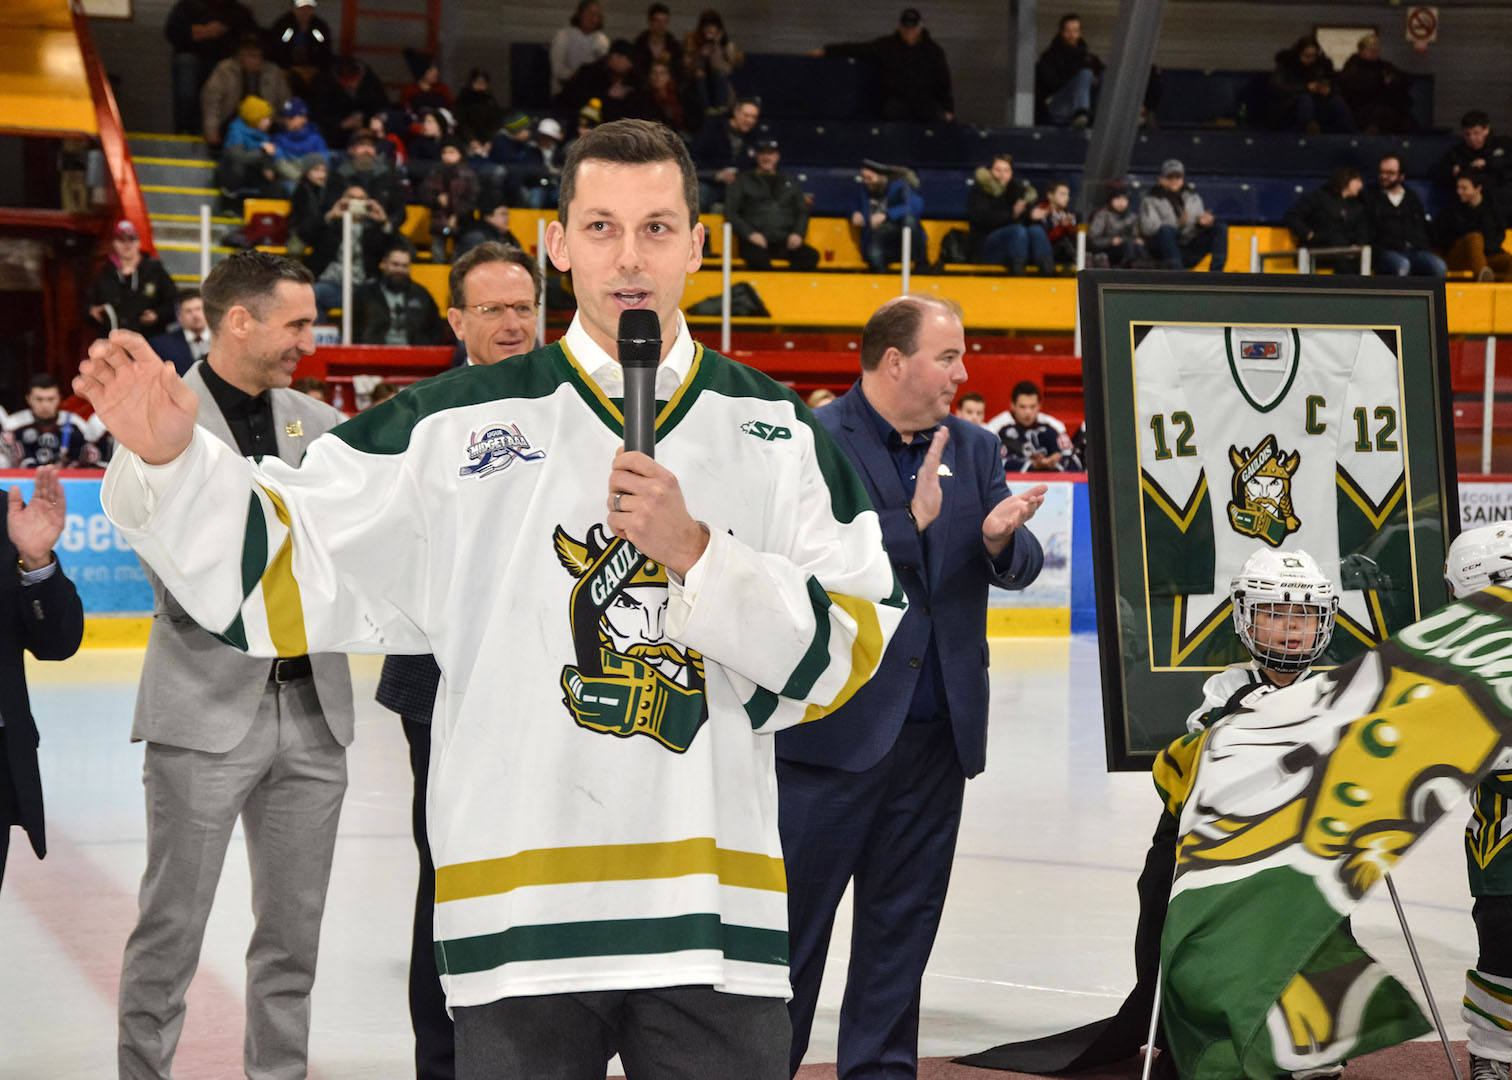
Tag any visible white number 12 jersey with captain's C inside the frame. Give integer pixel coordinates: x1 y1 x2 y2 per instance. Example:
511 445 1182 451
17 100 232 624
1134 325 1405 653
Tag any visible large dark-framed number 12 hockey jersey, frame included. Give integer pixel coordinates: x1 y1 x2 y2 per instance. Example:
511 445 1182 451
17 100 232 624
1080 271 1459 768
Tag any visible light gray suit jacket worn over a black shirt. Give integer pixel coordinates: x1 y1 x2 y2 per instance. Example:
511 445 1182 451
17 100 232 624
132 365 352 753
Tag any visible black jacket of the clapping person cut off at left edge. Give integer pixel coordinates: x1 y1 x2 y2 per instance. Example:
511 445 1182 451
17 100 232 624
0 528 85 870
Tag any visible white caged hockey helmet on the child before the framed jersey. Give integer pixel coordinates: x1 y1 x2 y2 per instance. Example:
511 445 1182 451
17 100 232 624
1229 548 1338 672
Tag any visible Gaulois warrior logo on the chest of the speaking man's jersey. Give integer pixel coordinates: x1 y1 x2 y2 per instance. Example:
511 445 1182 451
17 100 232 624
552 525 709 753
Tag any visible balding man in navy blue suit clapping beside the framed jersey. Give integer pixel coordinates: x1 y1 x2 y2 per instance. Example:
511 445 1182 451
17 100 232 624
777 296 1045 1080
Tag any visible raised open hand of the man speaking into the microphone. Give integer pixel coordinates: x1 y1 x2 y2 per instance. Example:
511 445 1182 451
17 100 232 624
74 330 200 464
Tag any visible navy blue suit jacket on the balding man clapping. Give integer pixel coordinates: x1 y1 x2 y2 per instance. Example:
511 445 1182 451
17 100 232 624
777 383 1045 776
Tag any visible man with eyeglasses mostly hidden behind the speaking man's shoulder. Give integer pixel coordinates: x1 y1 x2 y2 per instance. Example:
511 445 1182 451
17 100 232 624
376 242 541 1080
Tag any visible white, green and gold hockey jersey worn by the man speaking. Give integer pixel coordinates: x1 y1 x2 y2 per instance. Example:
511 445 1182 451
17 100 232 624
103 316 904 1006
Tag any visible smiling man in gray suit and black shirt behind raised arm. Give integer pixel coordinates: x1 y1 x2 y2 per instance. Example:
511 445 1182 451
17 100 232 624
118 251 352 1080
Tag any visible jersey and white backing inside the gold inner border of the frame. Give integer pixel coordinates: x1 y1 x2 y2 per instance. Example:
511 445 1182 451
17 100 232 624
1134 324 1415 669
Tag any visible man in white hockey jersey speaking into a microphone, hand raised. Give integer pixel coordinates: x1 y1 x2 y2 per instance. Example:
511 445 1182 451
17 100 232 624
76 121 904 1080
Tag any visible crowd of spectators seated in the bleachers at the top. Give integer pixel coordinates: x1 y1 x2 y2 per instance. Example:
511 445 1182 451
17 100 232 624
123 0 1512 343
